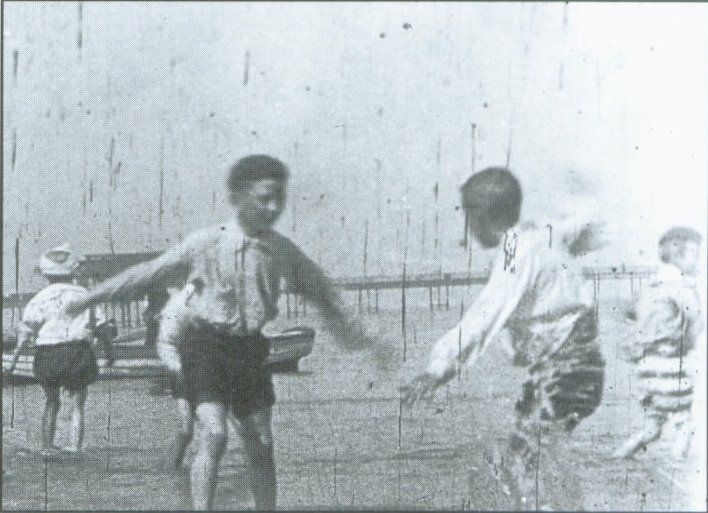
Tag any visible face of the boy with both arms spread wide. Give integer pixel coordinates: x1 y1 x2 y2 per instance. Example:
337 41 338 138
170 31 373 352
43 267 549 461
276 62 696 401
232 179 286 234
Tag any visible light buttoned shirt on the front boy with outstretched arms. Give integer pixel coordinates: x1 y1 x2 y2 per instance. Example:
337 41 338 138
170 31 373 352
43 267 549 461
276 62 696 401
80 220 363 342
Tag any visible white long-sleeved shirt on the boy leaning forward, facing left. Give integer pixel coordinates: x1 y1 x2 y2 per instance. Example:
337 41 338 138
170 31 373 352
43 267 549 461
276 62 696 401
427 225 595 378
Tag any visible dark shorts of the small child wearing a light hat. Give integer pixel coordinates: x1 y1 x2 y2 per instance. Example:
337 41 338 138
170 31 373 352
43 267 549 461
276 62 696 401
34 340 98 390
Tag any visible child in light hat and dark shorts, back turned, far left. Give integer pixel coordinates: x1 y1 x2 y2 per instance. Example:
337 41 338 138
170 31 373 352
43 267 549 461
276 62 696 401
8 244 116 455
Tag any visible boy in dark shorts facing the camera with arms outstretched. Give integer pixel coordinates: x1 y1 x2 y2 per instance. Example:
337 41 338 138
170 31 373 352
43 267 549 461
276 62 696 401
69 155 390 510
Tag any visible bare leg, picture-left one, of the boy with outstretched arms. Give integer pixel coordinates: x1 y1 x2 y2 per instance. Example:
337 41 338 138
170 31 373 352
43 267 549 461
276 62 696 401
192 402 227 510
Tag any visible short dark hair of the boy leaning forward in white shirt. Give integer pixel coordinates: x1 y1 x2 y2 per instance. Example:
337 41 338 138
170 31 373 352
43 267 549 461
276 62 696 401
460 167 523 228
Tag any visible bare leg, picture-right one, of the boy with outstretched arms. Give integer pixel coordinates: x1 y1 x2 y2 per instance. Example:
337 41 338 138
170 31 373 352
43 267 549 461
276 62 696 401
234 408 277 511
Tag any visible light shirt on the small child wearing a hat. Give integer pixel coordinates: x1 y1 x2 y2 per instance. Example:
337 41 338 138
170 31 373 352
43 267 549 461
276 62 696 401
19 283 106 346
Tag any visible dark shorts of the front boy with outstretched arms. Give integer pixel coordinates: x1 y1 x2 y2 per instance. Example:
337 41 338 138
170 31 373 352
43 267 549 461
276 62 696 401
178 327 275 418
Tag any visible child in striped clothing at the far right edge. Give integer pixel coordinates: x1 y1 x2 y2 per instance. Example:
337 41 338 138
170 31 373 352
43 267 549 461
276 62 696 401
613 227 703 459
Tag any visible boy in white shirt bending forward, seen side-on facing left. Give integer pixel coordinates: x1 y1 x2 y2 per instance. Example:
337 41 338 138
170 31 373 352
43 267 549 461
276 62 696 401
402 168 605 510
